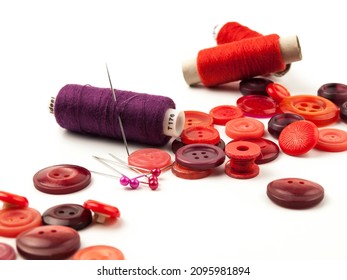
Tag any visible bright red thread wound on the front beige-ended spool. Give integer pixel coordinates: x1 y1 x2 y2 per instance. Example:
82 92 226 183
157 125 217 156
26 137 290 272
197 34 286 86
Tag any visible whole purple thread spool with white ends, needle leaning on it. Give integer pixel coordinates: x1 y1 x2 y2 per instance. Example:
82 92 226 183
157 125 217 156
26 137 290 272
50 84 185 146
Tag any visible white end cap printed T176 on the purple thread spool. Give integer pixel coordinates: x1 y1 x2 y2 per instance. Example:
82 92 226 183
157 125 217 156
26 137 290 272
163 109 185 137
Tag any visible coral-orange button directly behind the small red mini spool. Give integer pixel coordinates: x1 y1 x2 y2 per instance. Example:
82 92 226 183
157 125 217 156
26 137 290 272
225 118 265 140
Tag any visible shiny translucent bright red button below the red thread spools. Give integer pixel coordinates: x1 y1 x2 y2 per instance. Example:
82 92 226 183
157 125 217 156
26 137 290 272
236 95 278 118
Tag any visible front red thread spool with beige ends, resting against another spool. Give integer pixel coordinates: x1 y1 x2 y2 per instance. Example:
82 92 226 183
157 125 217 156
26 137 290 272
182 34 301 87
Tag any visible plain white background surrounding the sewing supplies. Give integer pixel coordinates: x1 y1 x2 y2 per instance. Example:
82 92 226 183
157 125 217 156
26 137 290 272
0 0 347 276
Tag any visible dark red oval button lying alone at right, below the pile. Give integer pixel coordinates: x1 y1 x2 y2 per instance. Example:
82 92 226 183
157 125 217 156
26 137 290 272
267 178 324 209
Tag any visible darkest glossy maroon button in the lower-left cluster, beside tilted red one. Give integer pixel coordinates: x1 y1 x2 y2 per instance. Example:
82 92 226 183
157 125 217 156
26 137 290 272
42 204 93 230
